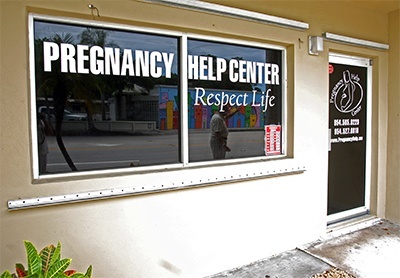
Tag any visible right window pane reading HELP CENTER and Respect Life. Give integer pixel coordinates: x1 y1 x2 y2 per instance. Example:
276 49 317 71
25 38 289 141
188 39 283 161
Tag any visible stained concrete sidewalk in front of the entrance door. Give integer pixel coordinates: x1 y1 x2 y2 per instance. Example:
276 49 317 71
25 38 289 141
209 219 400 278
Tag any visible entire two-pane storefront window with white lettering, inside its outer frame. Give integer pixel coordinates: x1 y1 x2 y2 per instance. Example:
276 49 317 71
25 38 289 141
31 18 285 176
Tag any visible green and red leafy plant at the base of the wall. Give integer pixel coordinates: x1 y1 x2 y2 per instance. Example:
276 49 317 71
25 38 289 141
0 241 92 278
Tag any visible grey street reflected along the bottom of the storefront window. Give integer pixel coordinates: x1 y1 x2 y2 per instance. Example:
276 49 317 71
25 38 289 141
47 130 264 173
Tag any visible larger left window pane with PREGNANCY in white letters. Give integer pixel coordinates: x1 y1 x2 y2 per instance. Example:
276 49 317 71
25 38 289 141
34 20 180 174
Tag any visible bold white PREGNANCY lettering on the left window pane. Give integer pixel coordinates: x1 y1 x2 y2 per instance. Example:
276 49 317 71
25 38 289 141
43 42 174 78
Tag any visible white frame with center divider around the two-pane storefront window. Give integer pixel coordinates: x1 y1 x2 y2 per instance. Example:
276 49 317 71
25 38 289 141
28 13 288 182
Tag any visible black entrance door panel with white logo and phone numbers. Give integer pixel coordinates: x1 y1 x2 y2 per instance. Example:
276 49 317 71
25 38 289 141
328 58 369 215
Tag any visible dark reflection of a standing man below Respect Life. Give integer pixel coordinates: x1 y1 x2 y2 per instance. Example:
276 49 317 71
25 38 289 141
210 106 234 159
